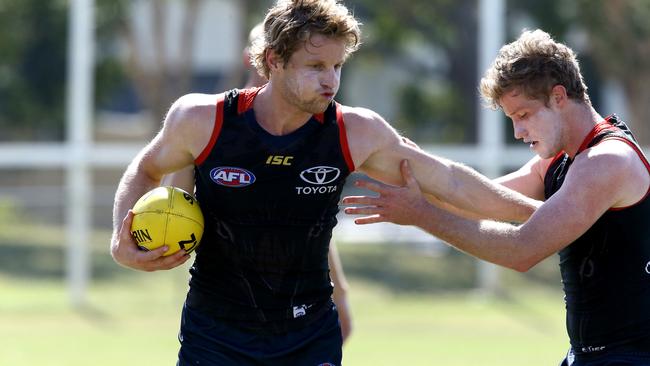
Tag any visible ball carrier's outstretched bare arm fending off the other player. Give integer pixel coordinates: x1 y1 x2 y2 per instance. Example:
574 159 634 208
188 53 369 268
344 107 541 222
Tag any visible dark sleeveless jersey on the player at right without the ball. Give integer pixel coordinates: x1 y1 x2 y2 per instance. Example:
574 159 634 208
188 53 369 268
544 115 650 354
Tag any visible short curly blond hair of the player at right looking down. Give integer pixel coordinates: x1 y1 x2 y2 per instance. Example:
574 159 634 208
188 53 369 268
480 29 591 109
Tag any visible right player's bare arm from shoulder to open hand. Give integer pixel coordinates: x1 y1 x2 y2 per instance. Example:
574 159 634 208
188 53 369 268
343 141 632 271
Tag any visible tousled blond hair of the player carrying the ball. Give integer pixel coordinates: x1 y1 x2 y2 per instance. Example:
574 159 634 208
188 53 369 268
250 0 361 79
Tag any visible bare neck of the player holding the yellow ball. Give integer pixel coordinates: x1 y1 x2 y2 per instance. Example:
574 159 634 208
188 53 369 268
253 83 312 136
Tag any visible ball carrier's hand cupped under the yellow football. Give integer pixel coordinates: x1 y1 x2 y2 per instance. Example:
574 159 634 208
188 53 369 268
111 210 190 272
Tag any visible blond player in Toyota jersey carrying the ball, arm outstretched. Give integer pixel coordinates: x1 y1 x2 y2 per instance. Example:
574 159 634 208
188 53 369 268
111 0 538 366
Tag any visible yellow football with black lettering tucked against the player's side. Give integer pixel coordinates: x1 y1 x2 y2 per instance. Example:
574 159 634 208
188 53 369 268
131 187 203 255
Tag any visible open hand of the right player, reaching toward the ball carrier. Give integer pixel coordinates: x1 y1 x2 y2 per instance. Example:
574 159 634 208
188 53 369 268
342 160 430 225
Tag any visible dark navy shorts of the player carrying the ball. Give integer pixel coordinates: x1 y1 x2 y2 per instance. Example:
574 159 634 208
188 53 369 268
176 304 343 366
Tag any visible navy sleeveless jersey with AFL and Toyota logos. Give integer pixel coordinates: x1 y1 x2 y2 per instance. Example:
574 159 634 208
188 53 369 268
187 88 354 331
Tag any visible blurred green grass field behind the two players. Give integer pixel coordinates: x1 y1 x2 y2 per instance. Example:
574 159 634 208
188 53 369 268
0 213 568 366
